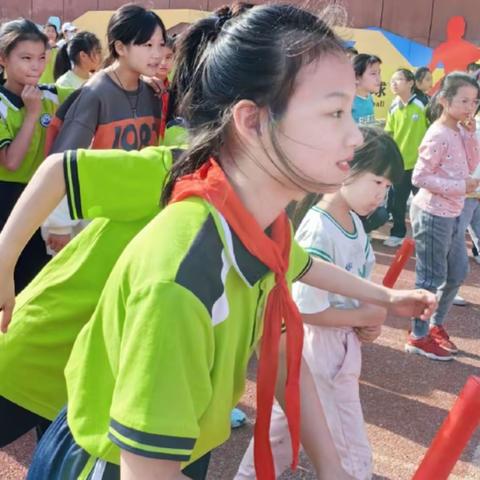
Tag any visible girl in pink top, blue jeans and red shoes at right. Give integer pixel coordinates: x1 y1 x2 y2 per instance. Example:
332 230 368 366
405 72 479 360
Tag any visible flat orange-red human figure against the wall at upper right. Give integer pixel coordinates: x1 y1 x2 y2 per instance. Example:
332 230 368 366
428 16 480 91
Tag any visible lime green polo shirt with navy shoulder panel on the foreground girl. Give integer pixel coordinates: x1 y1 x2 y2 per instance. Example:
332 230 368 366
66 198 310 474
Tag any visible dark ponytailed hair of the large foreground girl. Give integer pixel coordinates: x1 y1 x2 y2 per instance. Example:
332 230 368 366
162 4 346 204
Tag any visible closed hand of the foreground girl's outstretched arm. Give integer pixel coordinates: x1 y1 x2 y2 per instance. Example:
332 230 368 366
387 289 437 320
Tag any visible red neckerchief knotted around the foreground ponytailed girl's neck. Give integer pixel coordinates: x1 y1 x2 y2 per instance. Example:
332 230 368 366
171 158 303 480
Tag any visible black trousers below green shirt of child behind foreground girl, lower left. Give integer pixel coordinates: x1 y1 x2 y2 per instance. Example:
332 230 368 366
0 396 51 448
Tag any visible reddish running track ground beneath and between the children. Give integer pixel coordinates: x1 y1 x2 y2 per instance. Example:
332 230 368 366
0 228 480 480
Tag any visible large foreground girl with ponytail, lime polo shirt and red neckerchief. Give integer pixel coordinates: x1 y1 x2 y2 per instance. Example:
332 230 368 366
0 5 435 480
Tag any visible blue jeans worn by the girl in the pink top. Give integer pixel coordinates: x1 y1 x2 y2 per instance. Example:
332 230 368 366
410 204 468 338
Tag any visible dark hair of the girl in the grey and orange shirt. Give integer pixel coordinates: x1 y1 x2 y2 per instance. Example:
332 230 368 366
106 4 167 64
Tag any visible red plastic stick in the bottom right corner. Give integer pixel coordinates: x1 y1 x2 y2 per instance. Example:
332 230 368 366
412 376 480 480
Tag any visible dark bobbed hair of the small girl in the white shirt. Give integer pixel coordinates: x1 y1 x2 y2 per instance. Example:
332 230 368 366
287 125 404 230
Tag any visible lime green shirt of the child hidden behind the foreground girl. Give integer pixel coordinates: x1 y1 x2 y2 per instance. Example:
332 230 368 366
0 147 172 420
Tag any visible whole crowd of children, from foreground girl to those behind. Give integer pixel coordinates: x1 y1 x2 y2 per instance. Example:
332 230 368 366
0 4 480 480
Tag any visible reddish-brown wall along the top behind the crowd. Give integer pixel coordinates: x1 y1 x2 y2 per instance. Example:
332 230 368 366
0 0 480 46
